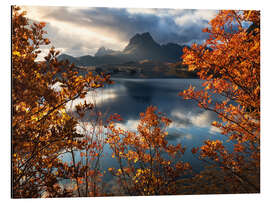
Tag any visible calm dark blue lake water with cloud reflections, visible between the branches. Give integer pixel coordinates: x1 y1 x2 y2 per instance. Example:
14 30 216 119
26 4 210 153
60 79 229 190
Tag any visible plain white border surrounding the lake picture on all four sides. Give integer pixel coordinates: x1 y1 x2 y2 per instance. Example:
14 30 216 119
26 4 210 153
0 0 270 203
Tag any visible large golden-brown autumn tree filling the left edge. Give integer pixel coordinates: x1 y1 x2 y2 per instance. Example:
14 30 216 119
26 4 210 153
11 6 110 198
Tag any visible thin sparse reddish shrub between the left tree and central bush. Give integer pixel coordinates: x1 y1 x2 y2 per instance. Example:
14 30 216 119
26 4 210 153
68 98 107 197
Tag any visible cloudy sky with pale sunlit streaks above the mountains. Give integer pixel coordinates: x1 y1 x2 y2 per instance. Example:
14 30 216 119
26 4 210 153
22 6 217 56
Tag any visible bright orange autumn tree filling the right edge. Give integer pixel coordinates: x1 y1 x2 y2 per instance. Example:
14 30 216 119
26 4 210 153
180 10 260 193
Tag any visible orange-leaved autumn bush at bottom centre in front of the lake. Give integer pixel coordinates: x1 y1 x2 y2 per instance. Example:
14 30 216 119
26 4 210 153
107 106 191 195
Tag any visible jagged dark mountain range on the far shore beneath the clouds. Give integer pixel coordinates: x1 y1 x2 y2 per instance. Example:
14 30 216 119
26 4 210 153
59 32 187 66
